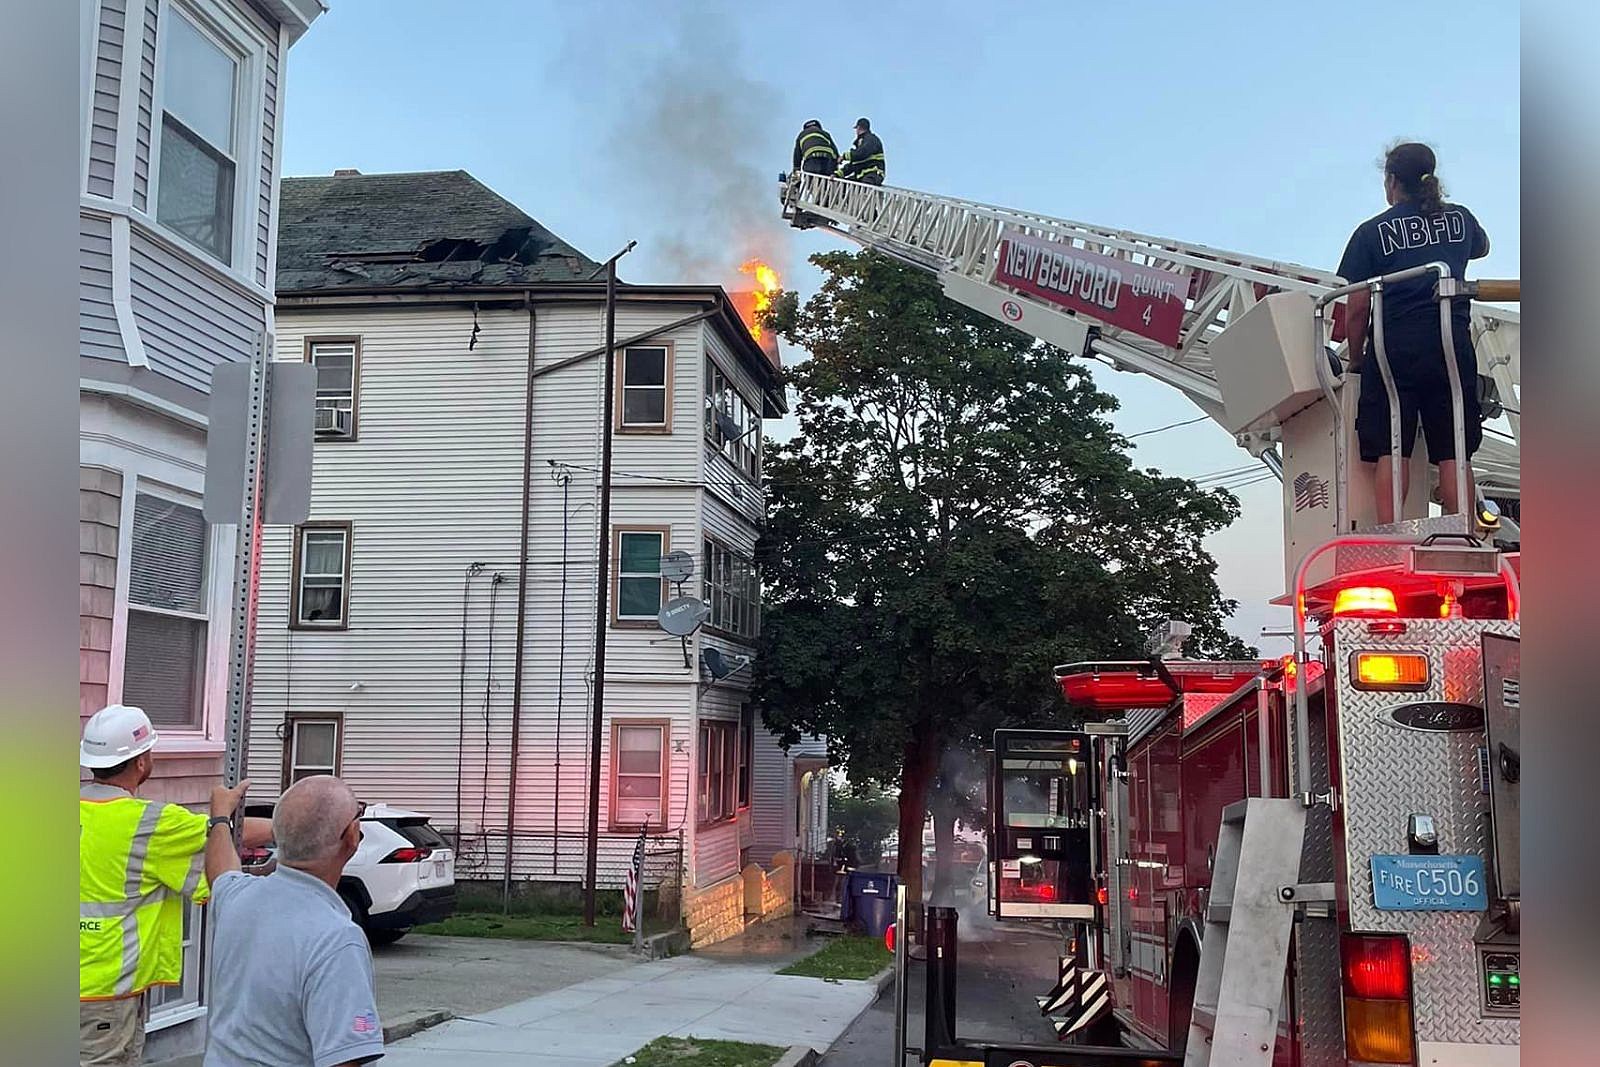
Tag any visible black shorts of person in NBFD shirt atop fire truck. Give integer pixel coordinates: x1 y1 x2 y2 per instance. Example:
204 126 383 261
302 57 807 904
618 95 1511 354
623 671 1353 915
1355 326 1483 464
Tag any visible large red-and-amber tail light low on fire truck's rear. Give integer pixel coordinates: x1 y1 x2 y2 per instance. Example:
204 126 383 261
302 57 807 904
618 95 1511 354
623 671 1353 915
1339 934 1416 1064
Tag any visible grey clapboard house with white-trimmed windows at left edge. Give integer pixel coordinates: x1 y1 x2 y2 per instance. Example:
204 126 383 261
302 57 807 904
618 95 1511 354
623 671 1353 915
78 0 325 1059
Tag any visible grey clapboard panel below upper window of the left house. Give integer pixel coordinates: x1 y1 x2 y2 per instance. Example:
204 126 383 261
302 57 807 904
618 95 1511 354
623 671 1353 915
131 226 266 392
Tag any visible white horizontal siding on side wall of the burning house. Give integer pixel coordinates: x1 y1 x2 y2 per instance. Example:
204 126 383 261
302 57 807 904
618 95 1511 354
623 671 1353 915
250 295 755 886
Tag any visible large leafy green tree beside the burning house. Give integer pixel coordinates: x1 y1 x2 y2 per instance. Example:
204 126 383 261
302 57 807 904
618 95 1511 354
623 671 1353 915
755 253 1246 899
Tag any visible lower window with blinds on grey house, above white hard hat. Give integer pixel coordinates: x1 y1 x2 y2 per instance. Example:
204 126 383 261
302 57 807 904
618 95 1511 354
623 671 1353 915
122 493 210 729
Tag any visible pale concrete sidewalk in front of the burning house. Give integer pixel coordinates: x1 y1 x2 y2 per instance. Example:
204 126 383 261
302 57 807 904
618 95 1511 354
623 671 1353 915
382 931 878 1067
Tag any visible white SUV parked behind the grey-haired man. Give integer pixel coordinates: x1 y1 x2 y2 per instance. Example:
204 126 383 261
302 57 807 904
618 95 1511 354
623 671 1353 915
240 805 456 945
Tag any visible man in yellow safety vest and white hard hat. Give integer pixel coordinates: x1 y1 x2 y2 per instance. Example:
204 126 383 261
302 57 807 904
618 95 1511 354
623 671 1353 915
78 704 272 1067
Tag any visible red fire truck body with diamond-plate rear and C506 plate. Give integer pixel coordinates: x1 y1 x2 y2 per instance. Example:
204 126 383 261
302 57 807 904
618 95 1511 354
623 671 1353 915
1056 557 1520 1067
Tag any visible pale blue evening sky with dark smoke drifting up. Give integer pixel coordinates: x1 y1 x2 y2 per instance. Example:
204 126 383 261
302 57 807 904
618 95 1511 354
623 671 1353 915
283 0 1522 653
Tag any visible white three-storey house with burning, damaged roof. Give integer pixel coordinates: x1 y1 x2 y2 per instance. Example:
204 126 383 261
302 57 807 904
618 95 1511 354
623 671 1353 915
250 171 819 942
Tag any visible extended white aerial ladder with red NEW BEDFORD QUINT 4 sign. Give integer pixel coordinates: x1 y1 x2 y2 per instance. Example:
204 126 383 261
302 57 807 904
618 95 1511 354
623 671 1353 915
781 173 1522 539
